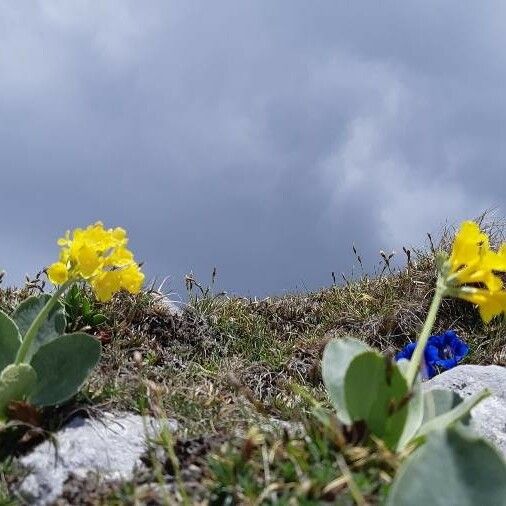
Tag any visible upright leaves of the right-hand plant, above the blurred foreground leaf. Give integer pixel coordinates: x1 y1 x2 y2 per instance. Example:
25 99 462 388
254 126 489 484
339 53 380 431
322 337 490 451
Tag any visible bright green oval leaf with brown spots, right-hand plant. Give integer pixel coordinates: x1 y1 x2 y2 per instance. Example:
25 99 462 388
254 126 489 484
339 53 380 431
344 351 409 448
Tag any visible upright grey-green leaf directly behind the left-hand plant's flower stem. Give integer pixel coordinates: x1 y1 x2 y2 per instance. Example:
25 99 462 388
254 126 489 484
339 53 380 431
12 294 67 361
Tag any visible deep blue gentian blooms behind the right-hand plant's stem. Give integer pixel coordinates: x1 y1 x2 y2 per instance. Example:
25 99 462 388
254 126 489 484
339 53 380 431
395 330 469 378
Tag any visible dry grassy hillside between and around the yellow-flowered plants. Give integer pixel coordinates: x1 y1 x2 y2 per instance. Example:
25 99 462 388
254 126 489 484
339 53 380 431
0 219 506 504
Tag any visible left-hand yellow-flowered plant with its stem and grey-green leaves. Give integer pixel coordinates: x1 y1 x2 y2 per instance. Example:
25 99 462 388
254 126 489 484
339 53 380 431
0 223 144 421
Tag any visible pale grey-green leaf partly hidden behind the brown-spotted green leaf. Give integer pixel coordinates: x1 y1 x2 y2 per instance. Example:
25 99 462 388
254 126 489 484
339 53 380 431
322 337 370 425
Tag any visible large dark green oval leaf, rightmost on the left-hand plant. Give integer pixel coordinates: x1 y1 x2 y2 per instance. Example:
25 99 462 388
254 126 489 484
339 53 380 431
31 333 101 406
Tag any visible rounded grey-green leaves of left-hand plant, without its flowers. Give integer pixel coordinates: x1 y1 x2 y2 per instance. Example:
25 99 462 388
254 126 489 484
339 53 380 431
0 294 101 421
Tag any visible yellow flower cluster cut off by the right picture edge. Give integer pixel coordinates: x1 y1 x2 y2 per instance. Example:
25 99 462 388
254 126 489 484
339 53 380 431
444 221 506 322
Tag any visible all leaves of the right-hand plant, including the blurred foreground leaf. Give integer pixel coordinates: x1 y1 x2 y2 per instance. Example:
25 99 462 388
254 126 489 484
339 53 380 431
322 337 506 505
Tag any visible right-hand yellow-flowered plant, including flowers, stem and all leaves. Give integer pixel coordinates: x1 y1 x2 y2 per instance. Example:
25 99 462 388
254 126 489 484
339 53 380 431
322 222 506 504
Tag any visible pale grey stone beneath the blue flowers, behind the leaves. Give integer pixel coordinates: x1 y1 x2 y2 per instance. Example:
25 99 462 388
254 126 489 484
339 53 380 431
424 365 506 456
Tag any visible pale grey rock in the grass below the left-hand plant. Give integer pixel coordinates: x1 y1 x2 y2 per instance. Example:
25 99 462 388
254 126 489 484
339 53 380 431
19 413 177 505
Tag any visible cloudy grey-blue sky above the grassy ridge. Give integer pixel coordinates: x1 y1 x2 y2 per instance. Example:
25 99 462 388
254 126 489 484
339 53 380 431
0 0 506 298
